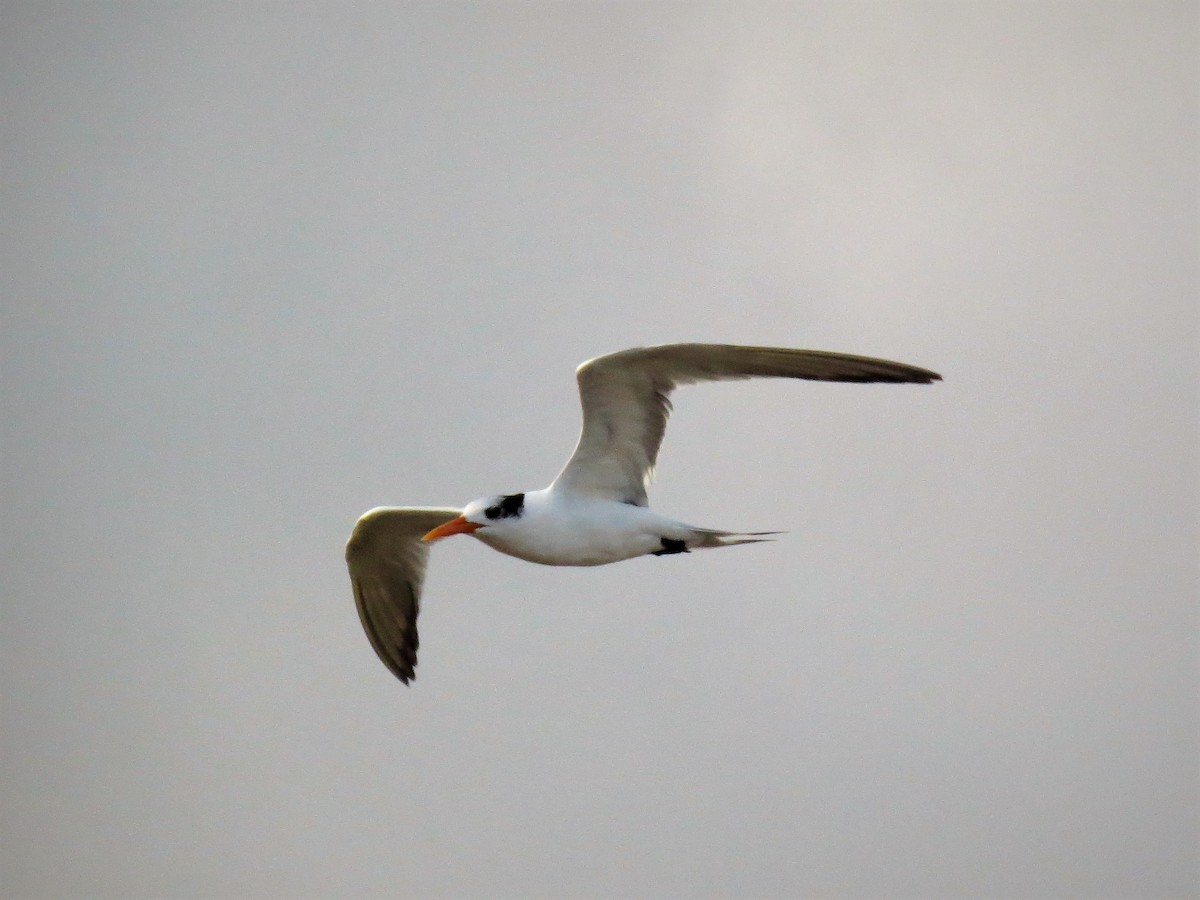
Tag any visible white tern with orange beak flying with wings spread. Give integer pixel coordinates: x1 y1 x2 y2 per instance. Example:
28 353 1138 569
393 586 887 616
346 343 941 684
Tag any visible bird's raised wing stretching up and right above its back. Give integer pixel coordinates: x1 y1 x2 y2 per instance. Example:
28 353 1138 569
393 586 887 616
553 343 941 506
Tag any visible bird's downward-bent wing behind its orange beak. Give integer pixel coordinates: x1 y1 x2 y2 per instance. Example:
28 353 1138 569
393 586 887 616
346 506 461 684
